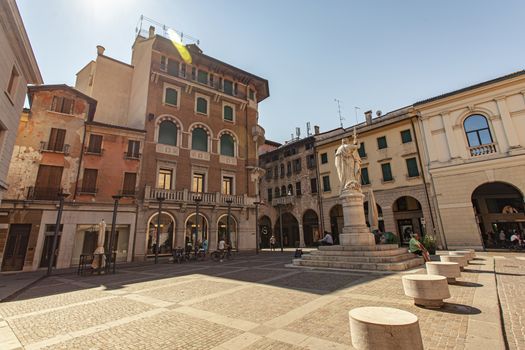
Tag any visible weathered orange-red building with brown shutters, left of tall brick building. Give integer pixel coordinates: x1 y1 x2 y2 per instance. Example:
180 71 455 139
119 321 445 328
0 85 144 271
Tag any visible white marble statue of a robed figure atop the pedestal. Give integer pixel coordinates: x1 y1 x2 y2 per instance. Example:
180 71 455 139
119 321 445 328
335 128 361 192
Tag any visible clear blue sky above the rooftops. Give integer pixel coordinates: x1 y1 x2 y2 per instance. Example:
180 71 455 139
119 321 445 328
18 0 525 142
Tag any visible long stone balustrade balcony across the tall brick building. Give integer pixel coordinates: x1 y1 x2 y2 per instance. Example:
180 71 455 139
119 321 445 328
145 186 248 205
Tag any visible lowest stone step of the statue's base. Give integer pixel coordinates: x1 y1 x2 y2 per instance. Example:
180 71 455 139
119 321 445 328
293 257 423 271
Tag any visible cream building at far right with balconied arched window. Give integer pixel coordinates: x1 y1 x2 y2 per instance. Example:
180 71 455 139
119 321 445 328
414 71 525 249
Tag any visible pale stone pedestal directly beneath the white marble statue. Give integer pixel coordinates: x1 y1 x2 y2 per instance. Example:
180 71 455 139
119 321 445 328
339 190 375 246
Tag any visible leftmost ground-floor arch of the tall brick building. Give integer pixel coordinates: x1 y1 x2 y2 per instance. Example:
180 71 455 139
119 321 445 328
146 211 175 255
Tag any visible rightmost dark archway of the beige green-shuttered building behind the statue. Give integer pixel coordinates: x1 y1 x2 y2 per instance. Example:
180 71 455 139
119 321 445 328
392 196 425 244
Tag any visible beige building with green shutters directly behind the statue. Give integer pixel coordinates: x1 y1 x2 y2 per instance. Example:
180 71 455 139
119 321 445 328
315 107 437 243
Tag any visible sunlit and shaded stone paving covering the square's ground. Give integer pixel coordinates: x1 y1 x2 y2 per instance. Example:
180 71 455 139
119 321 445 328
0 252 525 350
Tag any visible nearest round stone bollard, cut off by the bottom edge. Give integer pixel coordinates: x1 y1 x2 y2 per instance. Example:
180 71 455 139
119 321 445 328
348 306 423 350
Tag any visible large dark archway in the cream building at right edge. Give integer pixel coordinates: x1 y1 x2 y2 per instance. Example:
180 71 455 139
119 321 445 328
472 182 525 248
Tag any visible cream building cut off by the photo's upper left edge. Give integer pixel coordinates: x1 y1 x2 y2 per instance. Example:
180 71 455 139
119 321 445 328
0 0 42 204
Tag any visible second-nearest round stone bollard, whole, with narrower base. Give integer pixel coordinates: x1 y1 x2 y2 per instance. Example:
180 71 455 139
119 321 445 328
402 274 450 308
